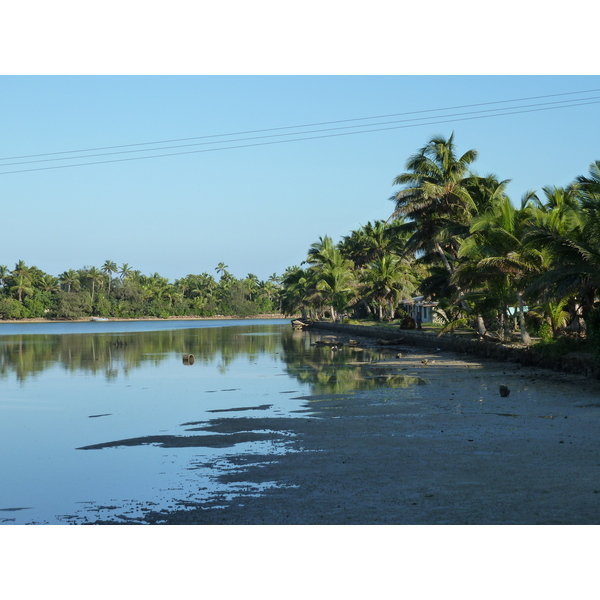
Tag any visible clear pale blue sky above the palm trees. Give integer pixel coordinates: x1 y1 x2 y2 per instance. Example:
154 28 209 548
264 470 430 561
0 75 600 281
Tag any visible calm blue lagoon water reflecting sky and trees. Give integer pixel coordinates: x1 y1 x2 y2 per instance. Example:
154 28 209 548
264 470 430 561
0 319 414 524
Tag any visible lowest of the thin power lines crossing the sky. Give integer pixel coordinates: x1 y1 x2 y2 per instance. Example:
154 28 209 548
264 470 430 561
0 94 600 175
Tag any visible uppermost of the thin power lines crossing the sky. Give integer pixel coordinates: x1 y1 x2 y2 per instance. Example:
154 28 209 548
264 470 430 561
0 89 600 161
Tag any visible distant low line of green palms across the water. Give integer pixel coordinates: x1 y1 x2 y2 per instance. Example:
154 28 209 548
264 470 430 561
0 260 279 319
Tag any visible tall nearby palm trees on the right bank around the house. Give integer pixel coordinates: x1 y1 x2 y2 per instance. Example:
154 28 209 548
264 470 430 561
282 134 600 343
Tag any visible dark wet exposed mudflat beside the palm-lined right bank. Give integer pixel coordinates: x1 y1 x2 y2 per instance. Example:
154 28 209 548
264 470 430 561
119 342 600 525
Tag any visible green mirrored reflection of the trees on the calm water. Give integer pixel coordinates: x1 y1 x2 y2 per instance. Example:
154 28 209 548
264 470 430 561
0 324 418 394
